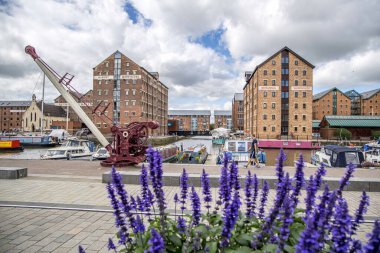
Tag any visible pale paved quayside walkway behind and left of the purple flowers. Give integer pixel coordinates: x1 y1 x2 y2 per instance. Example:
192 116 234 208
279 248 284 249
0 160 380 253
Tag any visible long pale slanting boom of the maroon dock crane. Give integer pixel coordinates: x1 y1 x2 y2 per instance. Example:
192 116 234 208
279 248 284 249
25 46 112 150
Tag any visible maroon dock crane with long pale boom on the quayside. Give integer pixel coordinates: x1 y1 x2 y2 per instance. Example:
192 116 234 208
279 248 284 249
25 46 159 166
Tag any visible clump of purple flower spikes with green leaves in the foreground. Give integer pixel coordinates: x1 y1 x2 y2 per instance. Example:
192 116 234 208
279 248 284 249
81 149 380 253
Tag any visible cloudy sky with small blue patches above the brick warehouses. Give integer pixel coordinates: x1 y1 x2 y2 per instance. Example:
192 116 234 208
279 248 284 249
0 0 380 110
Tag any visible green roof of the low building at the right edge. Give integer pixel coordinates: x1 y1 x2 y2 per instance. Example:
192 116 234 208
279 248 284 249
320 115 380 128
